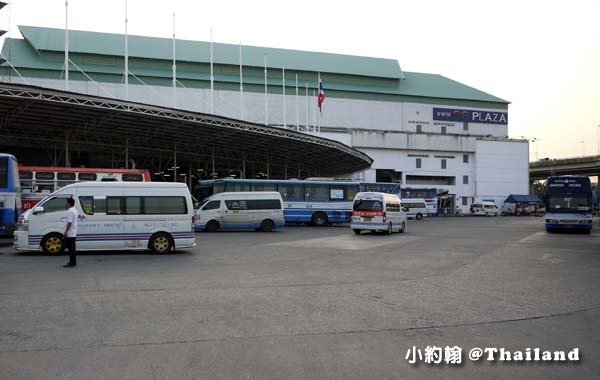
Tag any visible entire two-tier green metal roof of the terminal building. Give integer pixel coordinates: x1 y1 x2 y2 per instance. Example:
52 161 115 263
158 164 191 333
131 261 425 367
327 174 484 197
2 26 509 108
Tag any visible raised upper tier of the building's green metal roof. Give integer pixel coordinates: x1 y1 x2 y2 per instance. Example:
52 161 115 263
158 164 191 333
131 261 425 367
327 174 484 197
19 26 402 79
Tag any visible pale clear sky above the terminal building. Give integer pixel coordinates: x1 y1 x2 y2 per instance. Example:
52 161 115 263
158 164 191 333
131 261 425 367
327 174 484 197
0 0 600 159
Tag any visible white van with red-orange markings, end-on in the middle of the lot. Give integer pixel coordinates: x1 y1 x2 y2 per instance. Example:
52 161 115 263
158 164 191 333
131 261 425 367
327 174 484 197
350 192 406 235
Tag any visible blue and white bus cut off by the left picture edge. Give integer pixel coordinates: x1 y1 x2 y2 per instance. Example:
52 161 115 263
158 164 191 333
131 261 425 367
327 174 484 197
0 153 21 236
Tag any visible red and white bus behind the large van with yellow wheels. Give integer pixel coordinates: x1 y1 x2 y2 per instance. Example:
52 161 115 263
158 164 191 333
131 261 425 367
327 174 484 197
19 166 151 211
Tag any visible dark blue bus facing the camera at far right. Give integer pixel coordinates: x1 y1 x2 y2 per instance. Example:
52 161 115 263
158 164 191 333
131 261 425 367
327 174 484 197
544 176 592 232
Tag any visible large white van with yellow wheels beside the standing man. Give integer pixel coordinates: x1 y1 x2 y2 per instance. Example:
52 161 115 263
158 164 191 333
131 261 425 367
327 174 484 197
14 182 196 254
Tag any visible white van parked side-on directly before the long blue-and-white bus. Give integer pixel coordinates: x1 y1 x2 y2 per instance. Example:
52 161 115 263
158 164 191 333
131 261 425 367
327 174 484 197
196 191 285 232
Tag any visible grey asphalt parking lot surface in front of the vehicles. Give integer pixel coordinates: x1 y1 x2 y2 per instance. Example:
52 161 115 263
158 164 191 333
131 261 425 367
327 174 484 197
0 217 600 379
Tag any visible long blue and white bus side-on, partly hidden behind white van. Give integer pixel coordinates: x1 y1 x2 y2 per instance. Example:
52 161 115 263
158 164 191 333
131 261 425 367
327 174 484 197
197 178 359 226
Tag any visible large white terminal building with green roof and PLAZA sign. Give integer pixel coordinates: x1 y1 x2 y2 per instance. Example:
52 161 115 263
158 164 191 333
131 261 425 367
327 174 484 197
0 26 529 212
